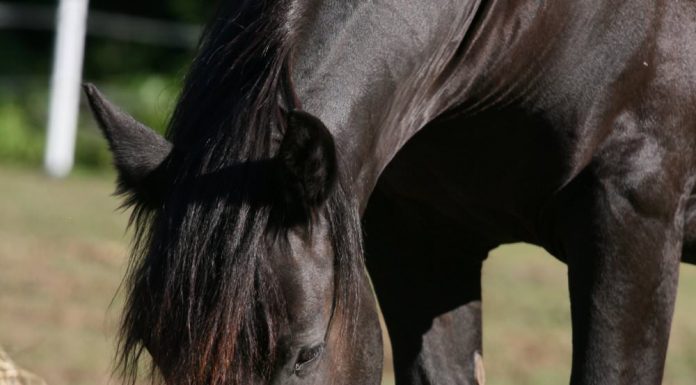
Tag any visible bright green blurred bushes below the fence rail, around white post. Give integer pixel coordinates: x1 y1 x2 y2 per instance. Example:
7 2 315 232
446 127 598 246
0 75 179 170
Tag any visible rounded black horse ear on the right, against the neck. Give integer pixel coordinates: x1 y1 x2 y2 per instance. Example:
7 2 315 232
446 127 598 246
276 111 337 211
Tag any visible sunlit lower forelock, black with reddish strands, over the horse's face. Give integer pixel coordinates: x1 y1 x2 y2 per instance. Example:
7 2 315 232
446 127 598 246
120 187 362 385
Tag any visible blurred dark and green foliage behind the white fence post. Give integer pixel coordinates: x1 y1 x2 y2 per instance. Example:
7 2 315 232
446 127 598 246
0 0 214 169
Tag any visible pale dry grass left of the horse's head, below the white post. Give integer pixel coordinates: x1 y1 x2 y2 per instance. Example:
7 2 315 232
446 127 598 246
0 168 127 385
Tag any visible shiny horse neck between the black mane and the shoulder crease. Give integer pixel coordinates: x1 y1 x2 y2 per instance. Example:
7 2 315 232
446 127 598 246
293 0 481 207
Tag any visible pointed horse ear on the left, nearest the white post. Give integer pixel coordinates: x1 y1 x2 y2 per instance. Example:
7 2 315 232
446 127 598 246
84 84 172 203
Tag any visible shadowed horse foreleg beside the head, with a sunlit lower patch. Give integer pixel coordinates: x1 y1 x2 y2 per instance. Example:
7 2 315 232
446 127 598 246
365 191 488 385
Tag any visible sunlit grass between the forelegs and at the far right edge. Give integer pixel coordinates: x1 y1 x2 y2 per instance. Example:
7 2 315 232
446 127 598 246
483 244 696 385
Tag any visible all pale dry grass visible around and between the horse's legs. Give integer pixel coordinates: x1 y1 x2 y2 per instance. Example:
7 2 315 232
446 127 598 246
0 167 696 385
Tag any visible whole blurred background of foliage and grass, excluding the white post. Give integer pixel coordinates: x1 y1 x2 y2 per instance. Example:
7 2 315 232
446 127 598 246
0 0 696 385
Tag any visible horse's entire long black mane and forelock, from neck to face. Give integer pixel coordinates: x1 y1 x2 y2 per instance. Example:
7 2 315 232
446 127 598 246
117 0 362 385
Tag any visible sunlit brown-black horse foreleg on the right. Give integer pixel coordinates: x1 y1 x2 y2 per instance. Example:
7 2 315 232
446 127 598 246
556 166 688 385
